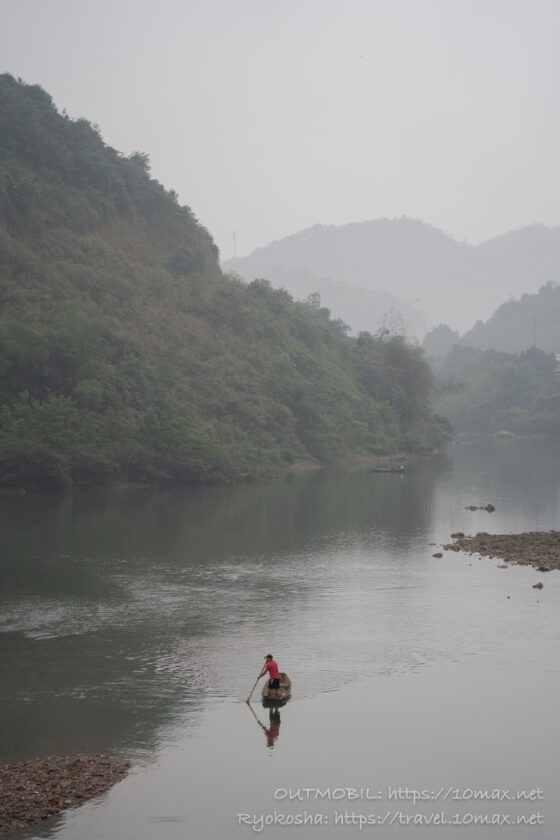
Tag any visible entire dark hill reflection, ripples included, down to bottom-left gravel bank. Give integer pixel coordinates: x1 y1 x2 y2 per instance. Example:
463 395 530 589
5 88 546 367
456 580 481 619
0 460 446 761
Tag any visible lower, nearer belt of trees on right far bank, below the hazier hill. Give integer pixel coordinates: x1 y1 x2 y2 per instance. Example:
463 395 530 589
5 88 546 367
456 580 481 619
435 345 560 435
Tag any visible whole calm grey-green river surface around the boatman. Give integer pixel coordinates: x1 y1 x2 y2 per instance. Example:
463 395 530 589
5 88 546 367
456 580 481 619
0 438 560 840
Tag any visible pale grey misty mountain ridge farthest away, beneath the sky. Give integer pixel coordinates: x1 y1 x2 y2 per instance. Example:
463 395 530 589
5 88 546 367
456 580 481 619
222 216 560 338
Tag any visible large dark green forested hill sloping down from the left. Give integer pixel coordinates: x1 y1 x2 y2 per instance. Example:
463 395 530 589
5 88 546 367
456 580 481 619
0 75 448 487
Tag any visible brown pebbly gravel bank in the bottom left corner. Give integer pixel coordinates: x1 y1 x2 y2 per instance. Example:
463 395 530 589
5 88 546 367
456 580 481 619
0 755 130 831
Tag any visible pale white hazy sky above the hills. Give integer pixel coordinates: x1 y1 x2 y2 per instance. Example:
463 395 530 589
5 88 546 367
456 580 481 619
0 0 560 259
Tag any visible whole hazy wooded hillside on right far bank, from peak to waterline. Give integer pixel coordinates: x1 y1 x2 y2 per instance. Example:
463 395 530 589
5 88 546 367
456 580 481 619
423 283 560 435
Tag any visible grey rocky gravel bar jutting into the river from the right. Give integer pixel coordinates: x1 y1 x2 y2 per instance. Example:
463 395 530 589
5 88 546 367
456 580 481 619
443 531 560 572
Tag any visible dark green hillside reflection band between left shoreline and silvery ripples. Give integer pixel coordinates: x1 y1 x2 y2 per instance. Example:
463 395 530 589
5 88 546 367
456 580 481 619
0 458 447 572
